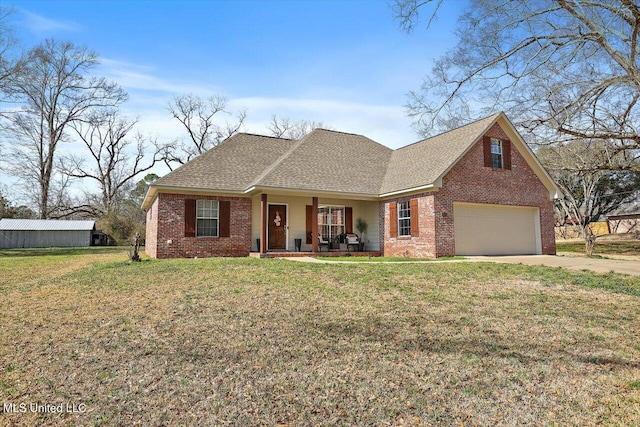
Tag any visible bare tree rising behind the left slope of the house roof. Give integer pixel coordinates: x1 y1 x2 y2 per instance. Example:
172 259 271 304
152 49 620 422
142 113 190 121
164 95 247 169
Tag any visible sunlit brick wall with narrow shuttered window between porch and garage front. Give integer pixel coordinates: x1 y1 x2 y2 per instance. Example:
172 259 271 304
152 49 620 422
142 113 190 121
379 193 436 258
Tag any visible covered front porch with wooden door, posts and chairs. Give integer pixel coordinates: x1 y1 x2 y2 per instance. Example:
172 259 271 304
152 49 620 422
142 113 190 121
251 192 381 258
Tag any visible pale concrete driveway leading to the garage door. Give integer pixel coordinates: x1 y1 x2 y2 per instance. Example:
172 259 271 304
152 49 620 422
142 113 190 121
467 255 640 276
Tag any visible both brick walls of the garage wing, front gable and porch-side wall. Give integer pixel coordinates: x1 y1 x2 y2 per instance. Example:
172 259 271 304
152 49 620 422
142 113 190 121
379 124 556 258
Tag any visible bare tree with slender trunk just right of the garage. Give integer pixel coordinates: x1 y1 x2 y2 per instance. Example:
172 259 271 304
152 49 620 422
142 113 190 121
538 140 640 255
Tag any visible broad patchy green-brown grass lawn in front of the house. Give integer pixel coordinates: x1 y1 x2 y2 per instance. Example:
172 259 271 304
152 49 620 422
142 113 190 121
0 249 640 426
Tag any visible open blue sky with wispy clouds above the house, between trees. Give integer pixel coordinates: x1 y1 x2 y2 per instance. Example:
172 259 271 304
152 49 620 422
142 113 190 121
3 0 464 189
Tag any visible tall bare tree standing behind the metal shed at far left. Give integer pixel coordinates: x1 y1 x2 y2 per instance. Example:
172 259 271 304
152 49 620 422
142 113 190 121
4 40 127 218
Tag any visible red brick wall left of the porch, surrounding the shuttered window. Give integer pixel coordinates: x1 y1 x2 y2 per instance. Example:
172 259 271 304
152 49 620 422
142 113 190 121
147 193 251 258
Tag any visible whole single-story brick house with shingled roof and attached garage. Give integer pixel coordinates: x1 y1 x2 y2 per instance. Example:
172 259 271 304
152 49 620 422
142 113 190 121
142 113 559 258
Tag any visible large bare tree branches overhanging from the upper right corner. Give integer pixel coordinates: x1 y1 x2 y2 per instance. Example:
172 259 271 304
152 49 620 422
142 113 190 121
393 0 640 169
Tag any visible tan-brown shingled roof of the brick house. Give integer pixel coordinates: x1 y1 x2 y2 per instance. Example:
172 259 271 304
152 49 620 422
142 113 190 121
143 113 557 208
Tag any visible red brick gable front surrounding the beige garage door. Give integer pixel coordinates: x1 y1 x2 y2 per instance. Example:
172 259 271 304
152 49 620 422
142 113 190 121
434 124 556 257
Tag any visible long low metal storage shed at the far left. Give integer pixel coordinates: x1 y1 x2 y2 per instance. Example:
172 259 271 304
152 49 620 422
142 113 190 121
0 218 96 249
